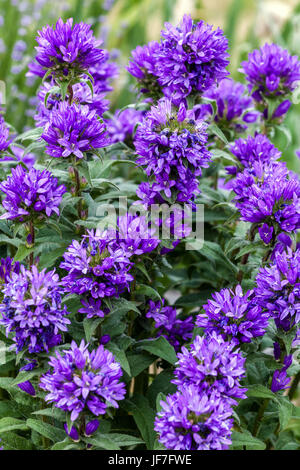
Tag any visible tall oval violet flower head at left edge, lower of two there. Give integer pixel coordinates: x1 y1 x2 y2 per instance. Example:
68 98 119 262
0 266 70 354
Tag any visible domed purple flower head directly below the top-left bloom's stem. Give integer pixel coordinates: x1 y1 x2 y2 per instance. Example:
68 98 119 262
42 103 110 159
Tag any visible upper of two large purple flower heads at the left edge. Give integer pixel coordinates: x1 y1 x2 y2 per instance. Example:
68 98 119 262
0 165 66 221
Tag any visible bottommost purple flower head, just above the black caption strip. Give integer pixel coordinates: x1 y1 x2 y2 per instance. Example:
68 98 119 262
154 385 233 450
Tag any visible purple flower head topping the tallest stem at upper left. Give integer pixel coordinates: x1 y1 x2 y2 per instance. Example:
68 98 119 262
36 18 104 79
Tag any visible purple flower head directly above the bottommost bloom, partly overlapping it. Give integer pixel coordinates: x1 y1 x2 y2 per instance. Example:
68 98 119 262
172 332 247 405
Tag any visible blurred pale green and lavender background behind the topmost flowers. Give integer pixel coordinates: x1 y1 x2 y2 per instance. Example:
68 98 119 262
0 0 300 171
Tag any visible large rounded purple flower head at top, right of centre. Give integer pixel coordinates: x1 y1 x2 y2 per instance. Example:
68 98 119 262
156 15 229 103
